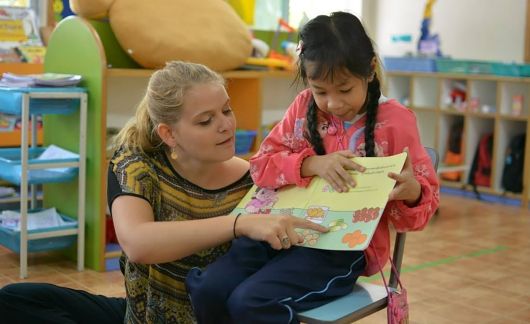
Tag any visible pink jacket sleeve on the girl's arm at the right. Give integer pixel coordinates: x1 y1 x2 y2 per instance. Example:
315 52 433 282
387 113 440 232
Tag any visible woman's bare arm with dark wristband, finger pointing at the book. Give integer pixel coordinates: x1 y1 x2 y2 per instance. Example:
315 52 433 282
112 195 327 264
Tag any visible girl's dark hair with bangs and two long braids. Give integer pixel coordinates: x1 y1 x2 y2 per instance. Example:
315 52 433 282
297 12 381 156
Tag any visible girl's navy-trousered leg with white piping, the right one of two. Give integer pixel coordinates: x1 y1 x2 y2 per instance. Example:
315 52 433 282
228 247 366 324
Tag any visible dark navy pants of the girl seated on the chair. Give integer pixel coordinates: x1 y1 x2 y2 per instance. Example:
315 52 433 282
186 238 366 324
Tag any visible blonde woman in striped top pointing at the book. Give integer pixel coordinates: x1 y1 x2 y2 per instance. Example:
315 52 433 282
0 62 326 323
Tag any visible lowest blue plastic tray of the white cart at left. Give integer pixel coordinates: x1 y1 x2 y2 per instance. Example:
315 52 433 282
0 214 77 253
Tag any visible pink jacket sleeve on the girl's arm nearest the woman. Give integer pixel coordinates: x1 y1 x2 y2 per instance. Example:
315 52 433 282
250 95 315 189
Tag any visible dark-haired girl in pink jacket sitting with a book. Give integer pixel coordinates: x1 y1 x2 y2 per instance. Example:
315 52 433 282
186 12 439 323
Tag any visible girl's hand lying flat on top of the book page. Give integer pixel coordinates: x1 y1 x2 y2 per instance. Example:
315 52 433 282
301 150 364 192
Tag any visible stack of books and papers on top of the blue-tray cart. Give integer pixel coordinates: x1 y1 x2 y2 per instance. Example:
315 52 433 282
0 73 82 88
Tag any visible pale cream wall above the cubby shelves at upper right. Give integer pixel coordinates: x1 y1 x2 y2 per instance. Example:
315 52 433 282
363 0 527 62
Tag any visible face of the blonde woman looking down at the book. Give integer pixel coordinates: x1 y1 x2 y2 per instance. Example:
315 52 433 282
173 82 236 162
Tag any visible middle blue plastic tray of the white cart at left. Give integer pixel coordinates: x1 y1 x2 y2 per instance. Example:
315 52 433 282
0 147 79 185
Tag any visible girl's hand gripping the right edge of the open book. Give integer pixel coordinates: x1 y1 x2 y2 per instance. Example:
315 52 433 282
388 147 421 206
